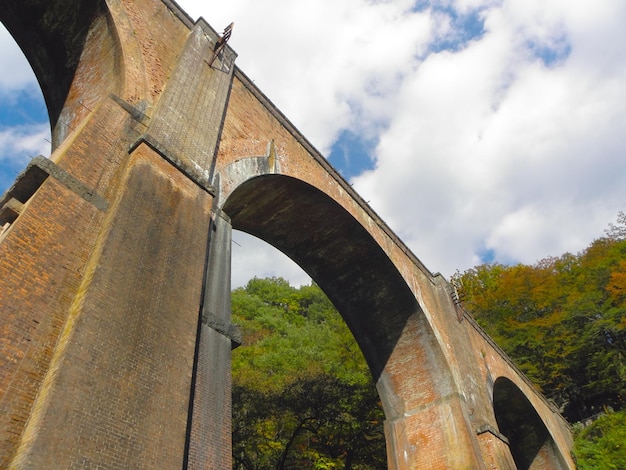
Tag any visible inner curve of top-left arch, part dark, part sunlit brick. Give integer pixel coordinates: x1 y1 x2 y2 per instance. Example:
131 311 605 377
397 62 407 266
0 0 151 151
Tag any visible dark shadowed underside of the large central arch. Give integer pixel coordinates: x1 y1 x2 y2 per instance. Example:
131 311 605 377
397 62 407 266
223 175 419 380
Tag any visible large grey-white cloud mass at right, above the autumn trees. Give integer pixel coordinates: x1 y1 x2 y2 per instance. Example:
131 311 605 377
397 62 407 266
355 2 626 275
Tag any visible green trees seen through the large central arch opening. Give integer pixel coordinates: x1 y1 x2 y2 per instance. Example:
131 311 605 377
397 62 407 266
232 278 386 470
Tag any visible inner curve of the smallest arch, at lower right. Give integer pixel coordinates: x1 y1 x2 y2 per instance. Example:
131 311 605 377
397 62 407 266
493 377 567 470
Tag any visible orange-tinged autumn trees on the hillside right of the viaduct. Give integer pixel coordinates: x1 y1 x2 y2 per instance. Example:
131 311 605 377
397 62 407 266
455 213 626 422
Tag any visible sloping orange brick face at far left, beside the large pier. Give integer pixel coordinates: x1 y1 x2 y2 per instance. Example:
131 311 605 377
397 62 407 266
0 180 102 468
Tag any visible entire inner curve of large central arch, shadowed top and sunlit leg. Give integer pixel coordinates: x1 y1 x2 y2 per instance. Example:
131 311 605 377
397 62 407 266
218 171 480 468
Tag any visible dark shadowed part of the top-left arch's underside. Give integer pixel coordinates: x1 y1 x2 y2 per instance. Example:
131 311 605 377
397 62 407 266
0 0 106 128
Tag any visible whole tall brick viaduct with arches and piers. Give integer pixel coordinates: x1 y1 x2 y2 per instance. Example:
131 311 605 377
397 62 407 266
0 0 574 469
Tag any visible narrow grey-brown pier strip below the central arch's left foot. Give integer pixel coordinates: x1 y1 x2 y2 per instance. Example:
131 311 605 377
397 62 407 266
185 213 240 469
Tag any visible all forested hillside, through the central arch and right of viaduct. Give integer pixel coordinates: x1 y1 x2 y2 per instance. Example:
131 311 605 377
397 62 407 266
233 213 626 470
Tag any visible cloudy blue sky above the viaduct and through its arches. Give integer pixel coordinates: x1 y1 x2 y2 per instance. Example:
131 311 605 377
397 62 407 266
0 0 626 285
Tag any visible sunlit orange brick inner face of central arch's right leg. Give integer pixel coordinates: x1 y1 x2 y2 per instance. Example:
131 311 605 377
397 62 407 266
377 311 485 470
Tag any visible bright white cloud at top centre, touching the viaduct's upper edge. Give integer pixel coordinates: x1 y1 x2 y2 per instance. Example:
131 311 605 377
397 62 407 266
180 0 432 154
